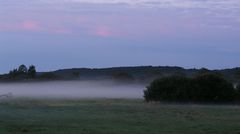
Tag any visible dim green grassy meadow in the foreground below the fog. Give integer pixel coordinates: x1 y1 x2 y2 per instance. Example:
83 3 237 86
0 99 240 134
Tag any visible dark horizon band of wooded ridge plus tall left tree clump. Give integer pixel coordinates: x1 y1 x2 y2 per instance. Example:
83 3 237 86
0 65 240 84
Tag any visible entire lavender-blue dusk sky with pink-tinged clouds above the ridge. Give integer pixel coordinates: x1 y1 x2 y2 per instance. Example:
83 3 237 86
0 0 240 73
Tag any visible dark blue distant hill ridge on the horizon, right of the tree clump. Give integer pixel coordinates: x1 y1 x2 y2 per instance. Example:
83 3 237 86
52 66 240 82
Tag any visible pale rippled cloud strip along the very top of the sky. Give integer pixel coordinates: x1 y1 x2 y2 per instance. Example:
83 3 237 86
42 0 240 9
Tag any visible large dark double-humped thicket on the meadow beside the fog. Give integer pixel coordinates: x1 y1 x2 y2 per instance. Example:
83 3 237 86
144 73 237 102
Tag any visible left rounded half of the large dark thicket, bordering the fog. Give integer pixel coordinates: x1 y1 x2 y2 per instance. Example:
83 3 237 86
144 76 192 101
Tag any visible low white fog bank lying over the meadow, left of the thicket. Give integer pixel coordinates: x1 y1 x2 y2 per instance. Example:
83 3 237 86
0 81 145 98
